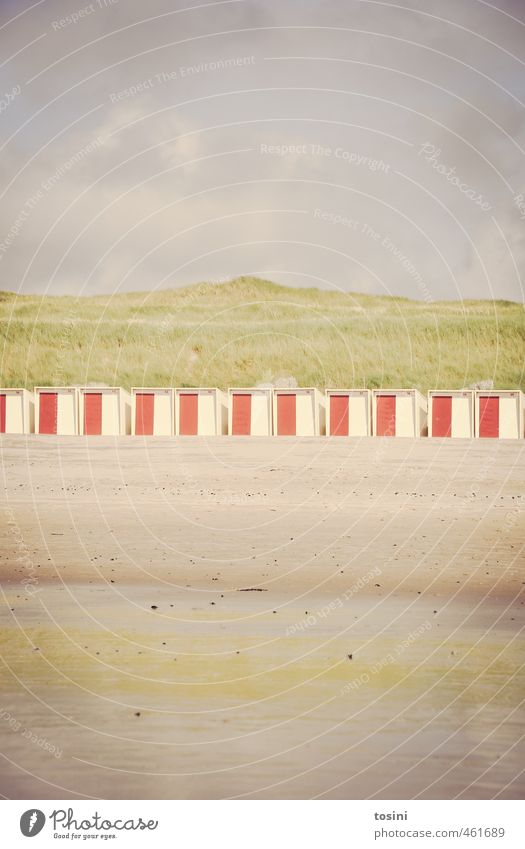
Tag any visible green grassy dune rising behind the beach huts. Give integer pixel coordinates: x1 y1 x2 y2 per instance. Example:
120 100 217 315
0 277 525 391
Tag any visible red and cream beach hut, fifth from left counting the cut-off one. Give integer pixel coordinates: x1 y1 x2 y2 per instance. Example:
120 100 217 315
175 389 228 436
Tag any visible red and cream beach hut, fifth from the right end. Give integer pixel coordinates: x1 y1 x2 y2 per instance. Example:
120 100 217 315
273 388 325 436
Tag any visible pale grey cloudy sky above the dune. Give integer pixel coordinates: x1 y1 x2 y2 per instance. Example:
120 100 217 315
0 0 525 302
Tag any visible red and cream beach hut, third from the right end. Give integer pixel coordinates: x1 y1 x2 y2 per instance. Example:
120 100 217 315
372 389 427 436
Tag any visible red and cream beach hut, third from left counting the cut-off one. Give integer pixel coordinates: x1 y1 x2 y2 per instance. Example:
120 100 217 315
78 386 131 436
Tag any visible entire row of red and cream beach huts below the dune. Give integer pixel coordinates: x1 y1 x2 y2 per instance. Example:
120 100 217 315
0 386 524 439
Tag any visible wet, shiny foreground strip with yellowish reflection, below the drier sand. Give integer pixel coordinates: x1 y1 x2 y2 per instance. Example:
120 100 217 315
0 584 525 798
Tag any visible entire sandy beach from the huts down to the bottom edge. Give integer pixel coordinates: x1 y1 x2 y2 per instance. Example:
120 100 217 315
0 437 525 799
